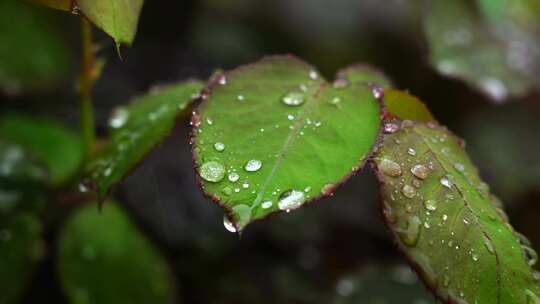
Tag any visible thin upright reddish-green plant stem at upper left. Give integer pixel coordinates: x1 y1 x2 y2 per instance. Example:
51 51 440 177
79 17 96 156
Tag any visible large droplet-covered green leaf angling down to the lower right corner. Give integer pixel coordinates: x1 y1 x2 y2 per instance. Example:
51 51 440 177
374 121 540 304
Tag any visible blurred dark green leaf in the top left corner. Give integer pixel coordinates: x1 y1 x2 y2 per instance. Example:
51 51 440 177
0 0 71 95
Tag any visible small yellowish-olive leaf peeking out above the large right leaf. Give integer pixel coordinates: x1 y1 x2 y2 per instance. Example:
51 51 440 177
384 90 435 122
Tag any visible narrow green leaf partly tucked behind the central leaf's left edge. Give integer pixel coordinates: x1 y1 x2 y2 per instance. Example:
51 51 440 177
84 81 203 198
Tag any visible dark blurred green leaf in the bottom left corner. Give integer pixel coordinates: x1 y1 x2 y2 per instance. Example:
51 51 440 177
0 214 44 304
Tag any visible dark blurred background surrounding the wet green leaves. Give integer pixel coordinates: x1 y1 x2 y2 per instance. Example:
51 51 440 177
0 0 540 304
